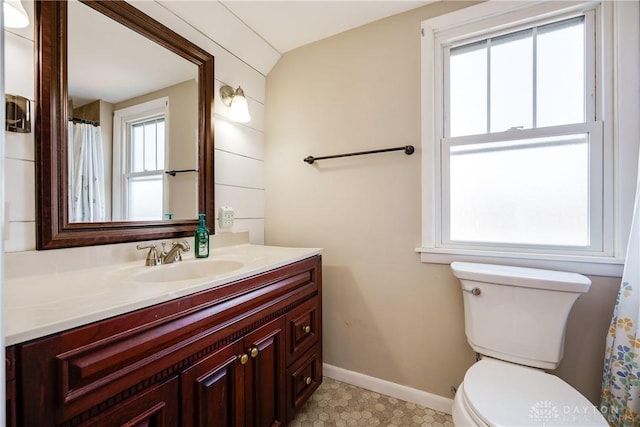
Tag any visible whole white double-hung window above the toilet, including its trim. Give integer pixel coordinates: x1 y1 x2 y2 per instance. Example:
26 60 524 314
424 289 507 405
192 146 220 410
418 2 636 274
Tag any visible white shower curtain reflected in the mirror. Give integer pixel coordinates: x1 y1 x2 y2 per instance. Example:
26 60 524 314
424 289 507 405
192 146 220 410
68 122 105 222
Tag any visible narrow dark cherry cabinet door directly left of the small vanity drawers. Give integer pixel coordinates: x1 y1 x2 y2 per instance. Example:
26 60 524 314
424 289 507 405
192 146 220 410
244 317 286 427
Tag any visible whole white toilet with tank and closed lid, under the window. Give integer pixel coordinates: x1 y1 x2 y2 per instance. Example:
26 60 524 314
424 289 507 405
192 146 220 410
451 262 608 427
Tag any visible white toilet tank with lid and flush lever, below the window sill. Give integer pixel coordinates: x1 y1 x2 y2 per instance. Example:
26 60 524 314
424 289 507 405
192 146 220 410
451 262 591 369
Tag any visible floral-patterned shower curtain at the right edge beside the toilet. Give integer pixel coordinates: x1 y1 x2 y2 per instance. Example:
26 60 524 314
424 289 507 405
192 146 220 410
601 152 640 427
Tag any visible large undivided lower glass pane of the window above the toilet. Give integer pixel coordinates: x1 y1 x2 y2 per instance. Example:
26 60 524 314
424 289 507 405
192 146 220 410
450 134 589 246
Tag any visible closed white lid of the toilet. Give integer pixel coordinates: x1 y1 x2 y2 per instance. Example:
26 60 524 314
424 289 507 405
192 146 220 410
463 359 608 427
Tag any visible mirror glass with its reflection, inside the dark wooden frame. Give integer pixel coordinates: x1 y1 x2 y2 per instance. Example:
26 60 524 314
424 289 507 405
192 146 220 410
66 2 198 222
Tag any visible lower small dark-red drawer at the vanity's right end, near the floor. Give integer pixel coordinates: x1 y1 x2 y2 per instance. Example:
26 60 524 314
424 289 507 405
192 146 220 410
287 344 322 421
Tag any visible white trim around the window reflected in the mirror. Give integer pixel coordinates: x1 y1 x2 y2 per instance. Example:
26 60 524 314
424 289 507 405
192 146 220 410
112 97 170 221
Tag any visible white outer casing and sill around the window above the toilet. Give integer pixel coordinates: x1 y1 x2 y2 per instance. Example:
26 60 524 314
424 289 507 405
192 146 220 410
416 1 640 276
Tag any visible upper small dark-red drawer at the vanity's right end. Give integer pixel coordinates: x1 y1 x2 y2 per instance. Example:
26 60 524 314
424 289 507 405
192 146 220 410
286 297 320 365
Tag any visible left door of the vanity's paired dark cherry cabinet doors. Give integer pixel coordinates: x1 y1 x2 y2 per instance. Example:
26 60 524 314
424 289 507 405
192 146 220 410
180 340 248 427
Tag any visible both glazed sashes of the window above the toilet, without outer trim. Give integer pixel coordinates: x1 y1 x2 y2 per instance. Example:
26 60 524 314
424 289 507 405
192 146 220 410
441 11 603 252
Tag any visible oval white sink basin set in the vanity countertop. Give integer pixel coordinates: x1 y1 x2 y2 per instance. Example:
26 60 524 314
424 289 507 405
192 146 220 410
133 259 244 283
